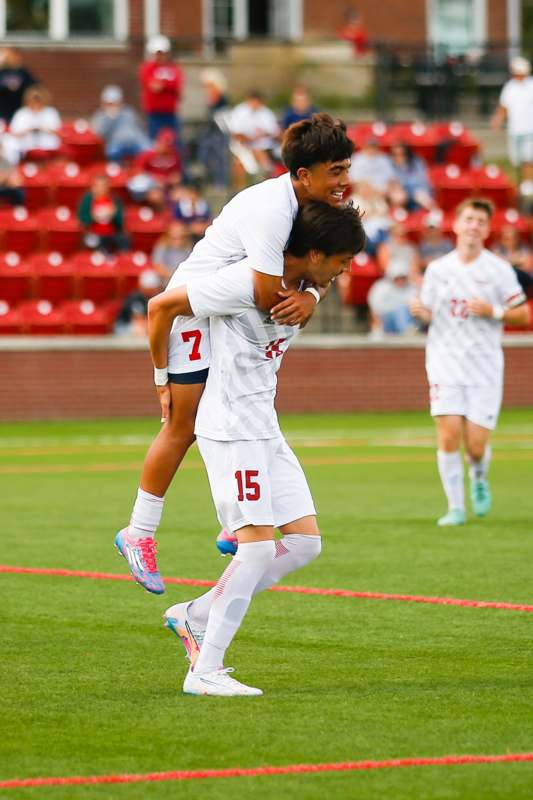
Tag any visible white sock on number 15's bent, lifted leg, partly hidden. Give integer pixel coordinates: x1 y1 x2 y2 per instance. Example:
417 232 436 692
187 533 322 627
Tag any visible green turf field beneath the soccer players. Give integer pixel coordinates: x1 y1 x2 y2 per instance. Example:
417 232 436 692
0 410 533 800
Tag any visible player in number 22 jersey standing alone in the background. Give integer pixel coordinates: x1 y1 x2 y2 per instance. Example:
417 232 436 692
411 198 529 526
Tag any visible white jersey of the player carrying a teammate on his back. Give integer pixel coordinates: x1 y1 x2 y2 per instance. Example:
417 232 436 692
187 259 299 442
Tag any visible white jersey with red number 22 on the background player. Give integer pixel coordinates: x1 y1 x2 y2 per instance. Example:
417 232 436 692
420 250 525 386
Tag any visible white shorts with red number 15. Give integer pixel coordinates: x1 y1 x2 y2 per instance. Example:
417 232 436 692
197 436 316 531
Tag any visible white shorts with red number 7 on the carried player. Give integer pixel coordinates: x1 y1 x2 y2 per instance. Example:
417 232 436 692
168 317 211 375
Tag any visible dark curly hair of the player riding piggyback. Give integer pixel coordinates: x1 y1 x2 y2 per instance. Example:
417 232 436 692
281 114 354 178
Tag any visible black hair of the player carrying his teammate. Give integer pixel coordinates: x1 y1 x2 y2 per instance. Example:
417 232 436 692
286 200 366 258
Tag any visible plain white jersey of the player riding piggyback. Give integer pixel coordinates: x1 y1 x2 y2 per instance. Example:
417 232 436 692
167 173 298 289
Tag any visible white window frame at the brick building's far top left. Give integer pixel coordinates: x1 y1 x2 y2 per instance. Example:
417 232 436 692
0 0 129 43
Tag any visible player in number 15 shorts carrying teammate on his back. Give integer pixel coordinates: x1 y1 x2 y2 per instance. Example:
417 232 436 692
149 202 365 696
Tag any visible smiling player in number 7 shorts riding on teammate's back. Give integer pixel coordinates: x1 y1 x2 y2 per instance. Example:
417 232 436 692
115 114 353 594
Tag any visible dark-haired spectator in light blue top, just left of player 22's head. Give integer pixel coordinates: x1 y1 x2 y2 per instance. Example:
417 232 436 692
389 142 435 211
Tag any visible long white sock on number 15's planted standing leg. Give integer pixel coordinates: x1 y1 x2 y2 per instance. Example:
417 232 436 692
194 540 276 673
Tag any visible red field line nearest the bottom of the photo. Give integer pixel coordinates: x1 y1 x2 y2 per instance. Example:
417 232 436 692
0 753 533 789
